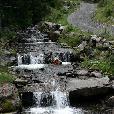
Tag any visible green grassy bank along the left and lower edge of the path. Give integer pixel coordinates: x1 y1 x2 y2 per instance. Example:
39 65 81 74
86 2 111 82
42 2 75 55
45 0 90 47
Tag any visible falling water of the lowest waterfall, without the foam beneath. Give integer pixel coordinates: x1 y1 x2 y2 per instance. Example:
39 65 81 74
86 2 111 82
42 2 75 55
34 91 68 109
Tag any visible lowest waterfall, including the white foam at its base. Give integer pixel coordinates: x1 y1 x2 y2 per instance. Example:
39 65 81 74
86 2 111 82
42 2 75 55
26 90 84 114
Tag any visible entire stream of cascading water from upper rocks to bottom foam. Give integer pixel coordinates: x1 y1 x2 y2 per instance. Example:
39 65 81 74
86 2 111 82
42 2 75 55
15 28 114 114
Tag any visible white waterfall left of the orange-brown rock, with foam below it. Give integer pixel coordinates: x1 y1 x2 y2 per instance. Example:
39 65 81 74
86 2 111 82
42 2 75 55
16 52 46 70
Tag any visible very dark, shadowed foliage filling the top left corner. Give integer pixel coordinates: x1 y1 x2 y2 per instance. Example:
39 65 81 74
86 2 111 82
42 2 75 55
0 0 61 28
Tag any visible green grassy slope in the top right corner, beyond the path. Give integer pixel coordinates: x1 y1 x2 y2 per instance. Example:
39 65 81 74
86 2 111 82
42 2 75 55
95 0 114 24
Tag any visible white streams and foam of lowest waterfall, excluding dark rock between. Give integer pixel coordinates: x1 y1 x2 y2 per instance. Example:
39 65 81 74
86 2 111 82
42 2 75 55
26 91 84 114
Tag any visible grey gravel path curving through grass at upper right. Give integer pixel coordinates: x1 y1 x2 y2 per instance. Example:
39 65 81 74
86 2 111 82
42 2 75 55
68 2 114 34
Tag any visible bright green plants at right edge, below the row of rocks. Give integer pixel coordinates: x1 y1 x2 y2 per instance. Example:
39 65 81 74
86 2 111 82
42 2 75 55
81 46 114 75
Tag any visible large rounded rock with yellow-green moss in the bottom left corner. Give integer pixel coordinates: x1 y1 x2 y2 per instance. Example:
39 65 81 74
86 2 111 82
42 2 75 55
0 84 20 113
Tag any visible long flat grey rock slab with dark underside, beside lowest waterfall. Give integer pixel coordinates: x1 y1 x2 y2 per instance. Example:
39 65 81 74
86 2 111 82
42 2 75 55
67 77 109 97
